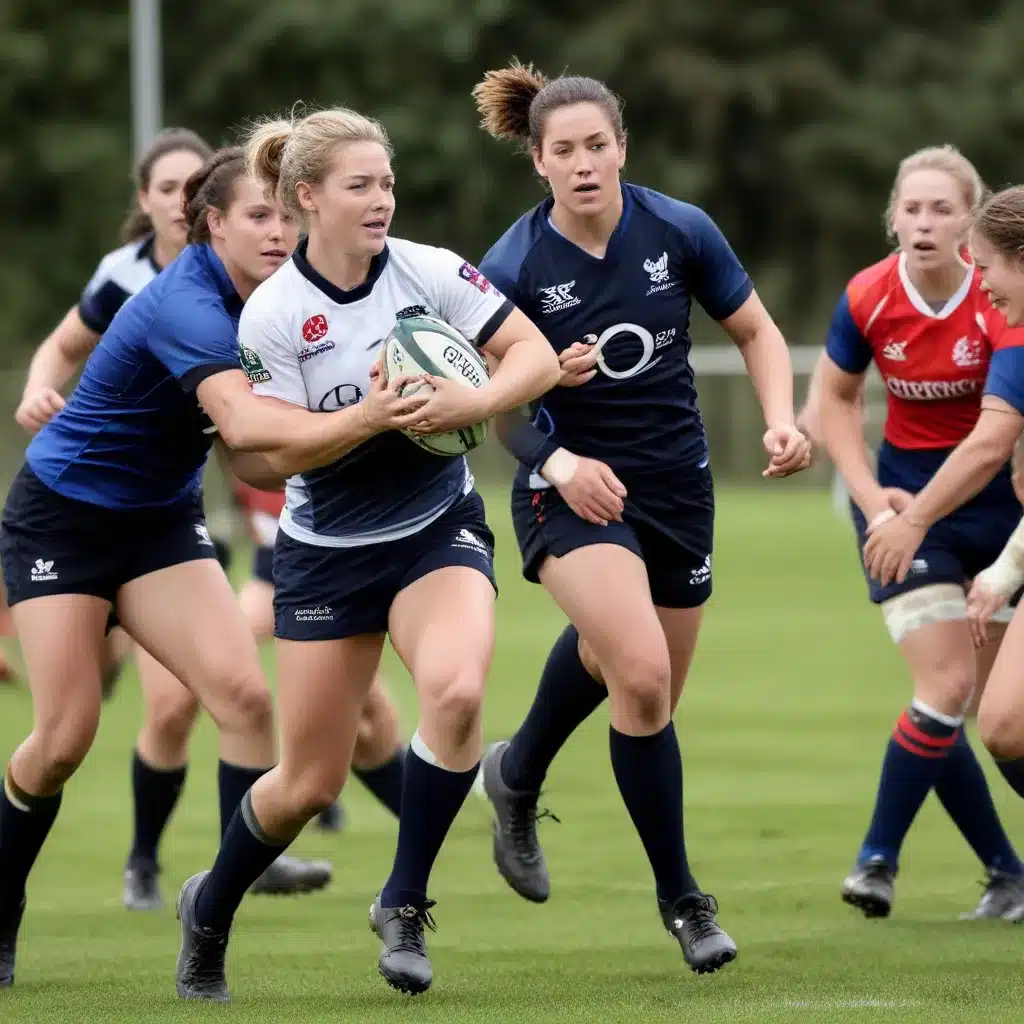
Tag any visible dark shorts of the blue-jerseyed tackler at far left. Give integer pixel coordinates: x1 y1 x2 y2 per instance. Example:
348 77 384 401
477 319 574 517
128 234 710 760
0 465 216 604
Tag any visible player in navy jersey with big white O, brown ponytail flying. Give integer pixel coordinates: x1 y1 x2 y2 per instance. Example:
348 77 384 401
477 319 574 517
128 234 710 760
475 65 809 973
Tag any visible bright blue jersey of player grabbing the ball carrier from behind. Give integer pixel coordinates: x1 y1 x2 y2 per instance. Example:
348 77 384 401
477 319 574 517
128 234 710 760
26 245 242 509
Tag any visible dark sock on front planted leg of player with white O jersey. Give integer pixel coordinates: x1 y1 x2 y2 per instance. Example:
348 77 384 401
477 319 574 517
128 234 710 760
608 722 699 904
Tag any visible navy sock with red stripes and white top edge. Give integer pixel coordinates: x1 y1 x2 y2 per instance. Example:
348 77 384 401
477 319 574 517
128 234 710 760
857 700 963 870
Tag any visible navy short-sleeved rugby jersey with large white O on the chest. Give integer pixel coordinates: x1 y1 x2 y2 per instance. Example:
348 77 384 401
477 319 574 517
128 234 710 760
480 183 754 474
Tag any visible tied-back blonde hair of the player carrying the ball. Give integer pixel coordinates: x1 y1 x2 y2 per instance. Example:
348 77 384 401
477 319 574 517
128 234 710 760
246 106 392 219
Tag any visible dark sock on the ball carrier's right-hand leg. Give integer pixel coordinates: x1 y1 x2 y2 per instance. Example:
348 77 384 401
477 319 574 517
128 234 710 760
381 737 478 908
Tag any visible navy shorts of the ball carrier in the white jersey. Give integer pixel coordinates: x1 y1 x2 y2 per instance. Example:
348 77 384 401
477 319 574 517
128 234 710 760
273 490 498 640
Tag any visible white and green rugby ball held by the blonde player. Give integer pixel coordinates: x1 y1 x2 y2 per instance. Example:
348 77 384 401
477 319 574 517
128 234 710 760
381 315 487 456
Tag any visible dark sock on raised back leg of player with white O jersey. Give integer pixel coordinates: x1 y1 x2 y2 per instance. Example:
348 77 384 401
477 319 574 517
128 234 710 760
502 626 608 793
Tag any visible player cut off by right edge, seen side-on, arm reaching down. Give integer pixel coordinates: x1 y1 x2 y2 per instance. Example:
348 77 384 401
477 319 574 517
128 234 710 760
864 186 1024 823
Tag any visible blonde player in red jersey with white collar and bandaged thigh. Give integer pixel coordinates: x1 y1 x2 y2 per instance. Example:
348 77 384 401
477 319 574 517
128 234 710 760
819 147 1024 921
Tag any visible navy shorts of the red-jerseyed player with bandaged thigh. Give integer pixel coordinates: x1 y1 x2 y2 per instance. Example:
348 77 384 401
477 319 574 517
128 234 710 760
850 444 1021 605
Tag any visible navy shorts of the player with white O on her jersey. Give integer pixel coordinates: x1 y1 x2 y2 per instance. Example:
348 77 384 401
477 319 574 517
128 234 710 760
512 466 715 608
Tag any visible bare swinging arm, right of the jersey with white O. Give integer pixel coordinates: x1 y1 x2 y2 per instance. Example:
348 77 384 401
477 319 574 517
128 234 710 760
722 292 811 476
